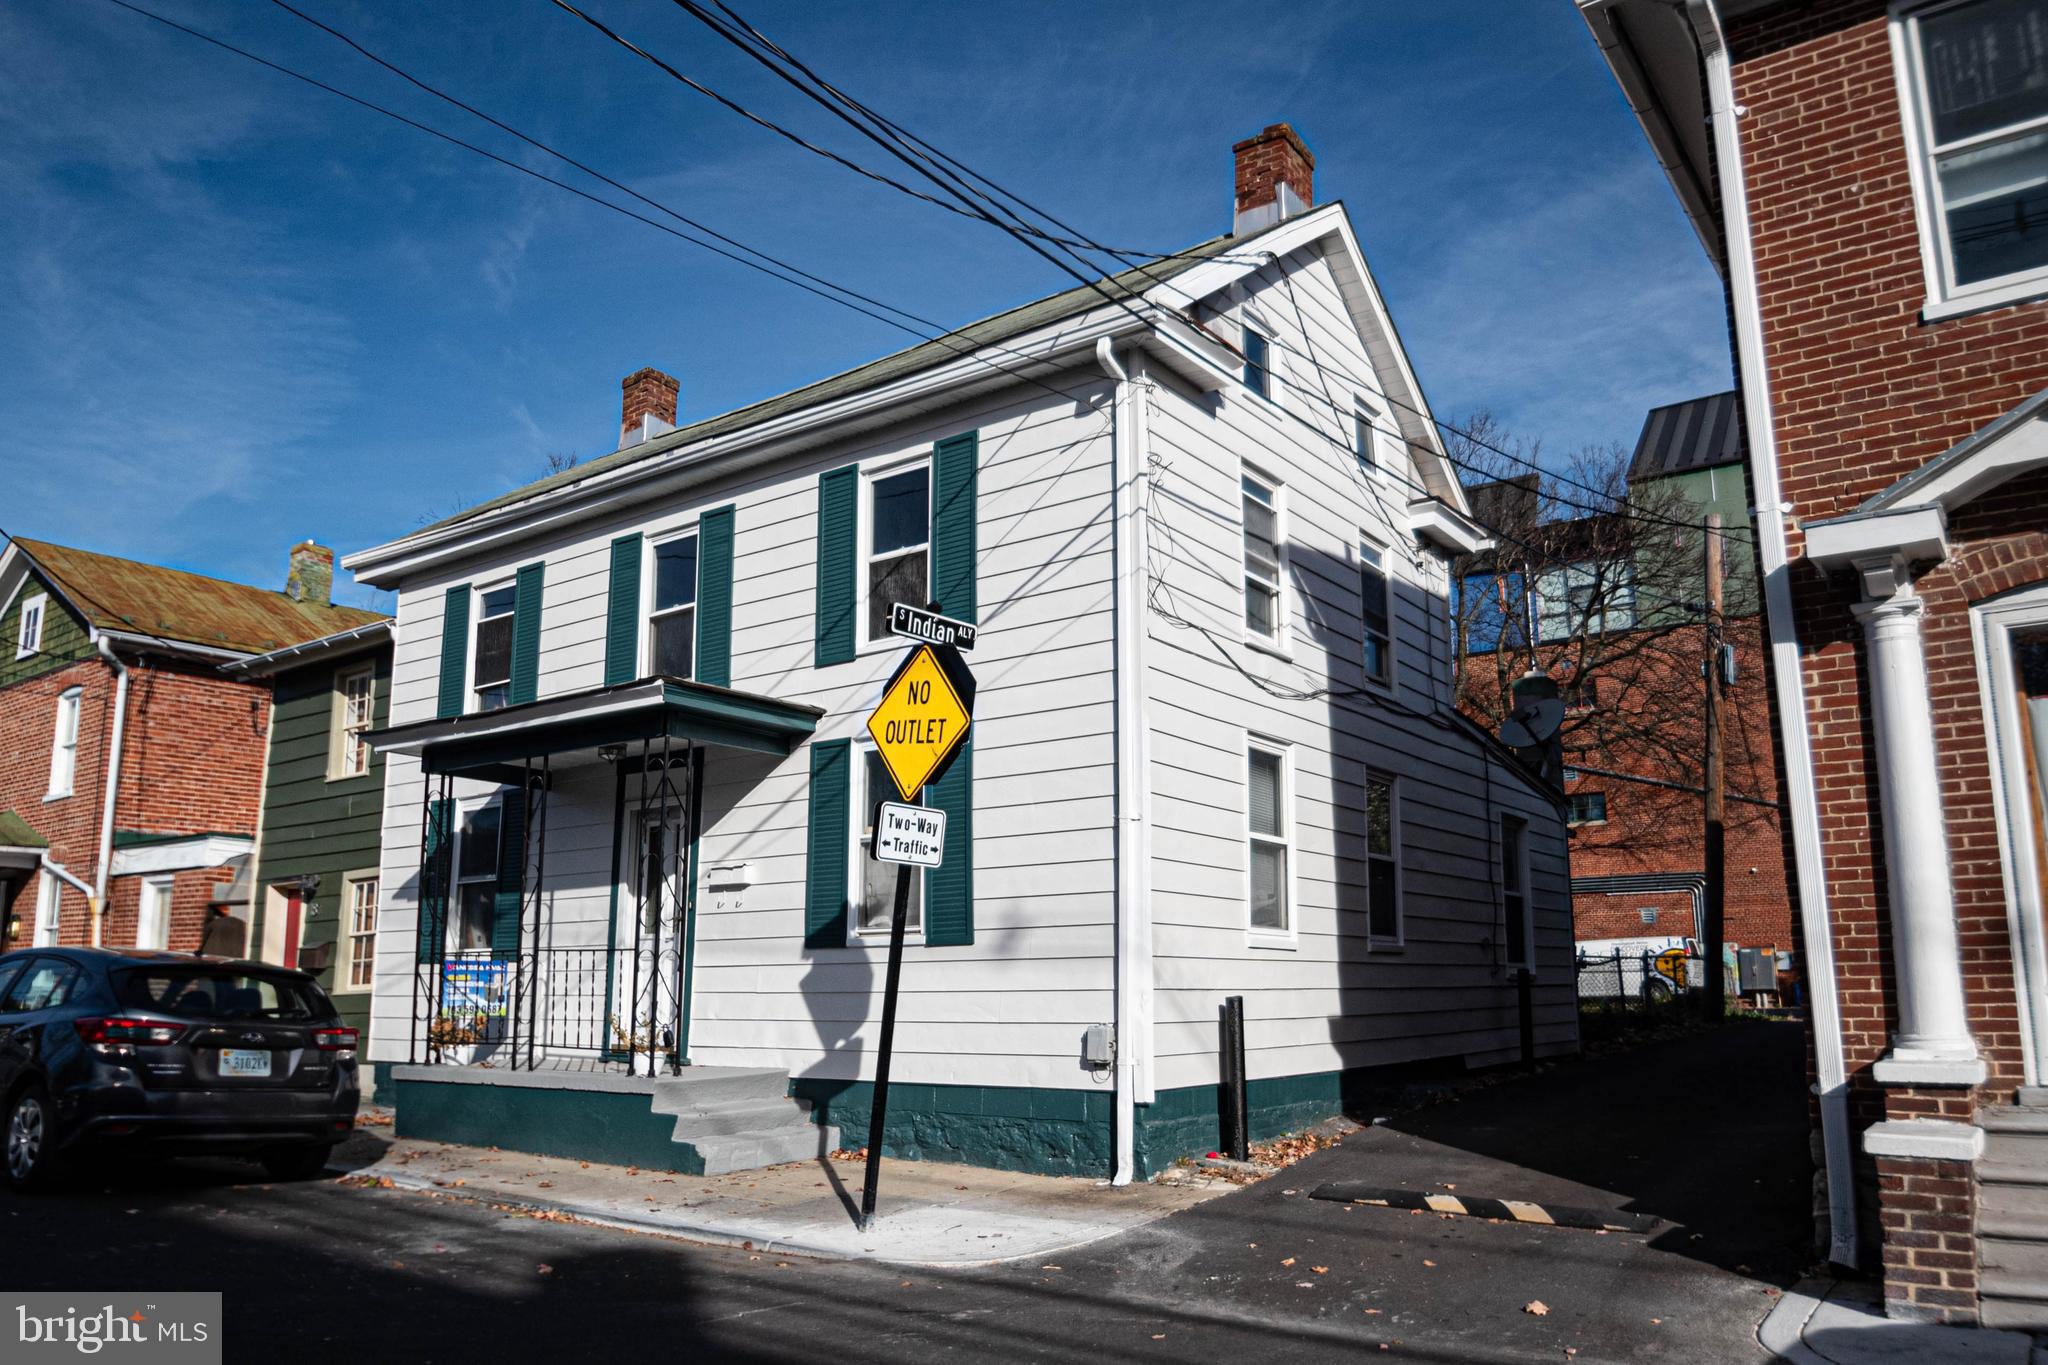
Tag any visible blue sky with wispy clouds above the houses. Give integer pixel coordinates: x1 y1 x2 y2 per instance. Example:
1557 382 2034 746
0 0 1731 602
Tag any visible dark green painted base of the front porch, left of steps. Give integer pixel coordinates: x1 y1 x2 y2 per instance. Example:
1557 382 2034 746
395 1081 705 1175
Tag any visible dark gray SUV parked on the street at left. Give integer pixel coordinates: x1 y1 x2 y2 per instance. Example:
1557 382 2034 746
0 948 360 1189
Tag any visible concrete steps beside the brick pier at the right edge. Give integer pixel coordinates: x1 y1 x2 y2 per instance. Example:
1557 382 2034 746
1976 1089 2048 1332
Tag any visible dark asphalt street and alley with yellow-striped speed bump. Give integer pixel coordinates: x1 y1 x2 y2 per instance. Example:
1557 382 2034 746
0 1023 1806 1365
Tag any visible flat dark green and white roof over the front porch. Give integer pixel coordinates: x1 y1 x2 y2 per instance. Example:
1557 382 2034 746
369 677 825 774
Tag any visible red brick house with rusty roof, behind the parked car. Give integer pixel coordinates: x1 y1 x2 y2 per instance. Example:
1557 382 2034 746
0 540 379 950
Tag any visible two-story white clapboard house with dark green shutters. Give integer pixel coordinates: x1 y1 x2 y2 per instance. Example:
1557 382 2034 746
346 125 1577 1179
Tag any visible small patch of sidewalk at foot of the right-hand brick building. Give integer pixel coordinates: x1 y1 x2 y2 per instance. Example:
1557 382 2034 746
1757 1279 2048 1365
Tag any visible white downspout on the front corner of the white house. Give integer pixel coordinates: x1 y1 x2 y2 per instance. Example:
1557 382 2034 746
1096 338 1153 1185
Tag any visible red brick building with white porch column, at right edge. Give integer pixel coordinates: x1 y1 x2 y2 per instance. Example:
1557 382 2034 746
1579 0 2048 1328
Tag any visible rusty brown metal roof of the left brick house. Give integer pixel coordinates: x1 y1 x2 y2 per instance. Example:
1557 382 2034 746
14 538 385 655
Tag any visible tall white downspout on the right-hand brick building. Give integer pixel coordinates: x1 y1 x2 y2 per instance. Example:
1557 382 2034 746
1688 0 1855 1267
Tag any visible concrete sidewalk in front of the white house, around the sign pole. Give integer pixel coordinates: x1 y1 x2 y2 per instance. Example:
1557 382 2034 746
346 1138 1231 1267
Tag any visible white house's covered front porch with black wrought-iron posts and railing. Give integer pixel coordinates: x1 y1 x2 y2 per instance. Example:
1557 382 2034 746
373 677 821 1089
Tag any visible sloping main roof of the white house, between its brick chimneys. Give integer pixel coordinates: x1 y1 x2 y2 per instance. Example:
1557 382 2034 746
422 224 1269 530
